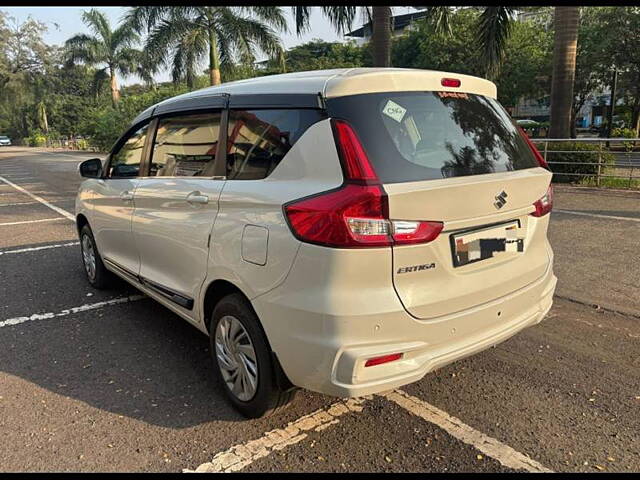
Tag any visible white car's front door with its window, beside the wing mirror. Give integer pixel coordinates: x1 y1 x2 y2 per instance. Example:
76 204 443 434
91 123 149 275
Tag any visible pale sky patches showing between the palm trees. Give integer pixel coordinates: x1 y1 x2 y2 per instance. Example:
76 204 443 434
0 7 410 85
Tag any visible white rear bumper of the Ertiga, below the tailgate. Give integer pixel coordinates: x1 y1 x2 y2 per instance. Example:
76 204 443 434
253 262 557 397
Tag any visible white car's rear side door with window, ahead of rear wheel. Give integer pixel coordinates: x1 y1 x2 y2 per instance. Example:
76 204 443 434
133 110 224 319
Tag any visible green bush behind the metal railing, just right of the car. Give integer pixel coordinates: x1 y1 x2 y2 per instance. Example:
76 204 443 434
539 142 614 183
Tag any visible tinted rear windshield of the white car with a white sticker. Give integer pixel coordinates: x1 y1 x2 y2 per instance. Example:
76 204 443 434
327 92 538 183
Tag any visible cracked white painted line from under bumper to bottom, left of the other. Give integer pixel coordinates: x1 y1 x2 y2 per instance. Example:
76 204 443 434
188 396 371 473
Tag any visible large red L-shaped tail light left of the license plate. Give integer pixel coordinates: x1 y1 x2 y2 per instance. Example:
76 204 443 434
284 120 443 248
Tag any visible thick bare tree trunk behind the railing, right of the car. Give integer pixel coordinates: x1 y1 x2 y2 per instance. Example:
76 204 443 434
549 7 580 138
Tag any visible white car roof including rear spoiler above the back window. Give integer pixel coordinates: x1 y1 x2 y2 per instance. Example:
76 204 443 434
133 67 497 123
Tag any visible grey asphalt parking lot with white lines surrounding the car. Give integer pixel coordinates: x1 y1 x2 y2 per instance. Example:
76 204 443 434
0 148 640 472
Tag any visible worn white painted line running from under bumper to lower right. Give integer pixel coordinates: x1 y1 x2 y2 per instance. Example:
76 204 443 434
382 390 552 473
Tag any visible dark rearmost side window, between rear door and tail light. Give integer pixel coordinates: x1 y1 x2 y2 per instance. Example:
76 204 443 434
227 109 324 180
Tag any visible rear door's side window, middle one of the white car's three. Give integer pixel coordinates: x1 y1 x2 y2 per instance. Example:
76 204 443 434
149 113 220 177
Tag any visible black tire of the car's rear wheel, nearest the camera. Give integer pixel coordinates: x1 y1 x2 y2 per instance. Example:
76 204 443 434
209 293 296 418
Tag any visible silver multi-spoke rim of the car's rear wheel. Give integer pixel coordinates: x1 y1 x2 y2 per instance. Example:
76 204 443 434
215 315 258 402
